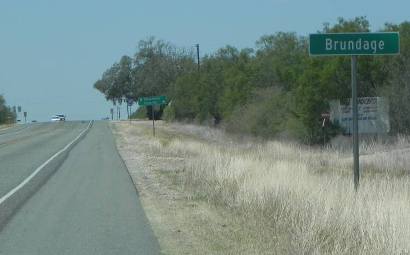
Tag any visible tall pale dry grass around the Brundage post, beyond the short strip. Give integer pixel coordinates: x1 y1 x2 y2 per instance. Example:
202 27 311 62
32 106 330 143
112 123 410 254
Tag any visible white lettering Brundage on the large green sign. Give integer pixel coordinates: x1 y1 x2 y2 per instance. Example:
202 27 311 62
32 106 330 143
325 38 384 53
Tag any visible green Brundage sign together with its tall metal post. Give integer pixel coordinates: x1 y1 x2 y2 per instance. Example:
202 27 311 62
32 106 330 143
309 32 400 191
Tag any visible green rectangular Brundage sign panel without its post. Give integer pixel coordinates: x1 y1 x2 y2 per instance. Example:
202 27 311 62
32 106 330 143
309 32 400 56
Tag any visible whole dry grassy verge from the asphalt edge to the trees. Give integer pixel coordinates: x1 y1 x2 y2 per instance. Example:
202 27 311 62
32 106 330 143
114 122 410 254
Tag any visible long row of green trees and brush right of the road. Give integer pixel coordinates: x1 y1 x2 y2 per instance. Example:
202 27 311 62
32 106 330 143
94 17 410 143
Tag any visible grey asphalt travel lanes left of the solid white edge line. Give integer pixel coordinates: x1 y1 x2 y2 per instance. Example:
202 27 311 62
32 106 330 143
0 122 88 197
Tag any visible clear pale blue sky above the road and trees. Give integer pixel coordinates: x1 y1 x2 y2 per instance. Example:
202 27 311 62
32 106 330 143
0 0 410 121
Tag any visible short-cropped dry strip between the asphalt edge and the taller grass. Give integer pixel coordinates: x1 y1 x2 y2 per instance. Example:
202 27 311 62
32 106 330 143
111 122 258 254
